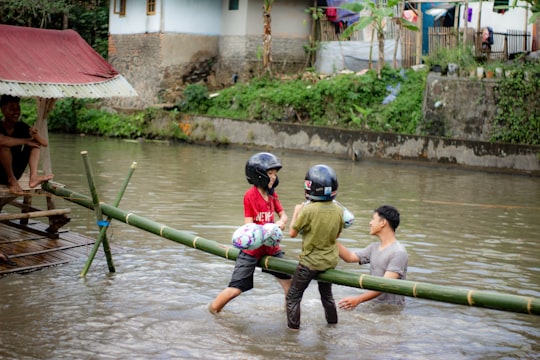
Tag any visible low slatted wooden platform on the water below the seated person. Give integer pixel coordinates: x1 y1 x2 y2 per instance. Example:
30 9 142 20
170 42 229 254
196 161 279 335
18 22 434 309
0 219 95 276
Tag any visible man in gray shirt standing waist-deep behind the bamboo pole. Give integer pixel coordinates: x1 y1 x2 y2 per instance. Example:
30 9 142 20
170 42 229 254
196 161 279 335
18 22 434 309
338 205 408 310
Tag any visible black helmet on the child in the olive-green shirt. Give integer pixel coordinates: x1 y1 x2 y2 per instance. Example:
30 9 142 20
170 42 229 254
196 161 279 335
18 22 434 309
304 165 338 201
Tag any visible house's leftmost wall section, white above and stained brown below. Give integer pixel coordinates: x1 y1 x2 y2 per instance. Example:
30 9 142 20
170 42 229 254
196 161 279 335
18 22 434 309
108 0 221 108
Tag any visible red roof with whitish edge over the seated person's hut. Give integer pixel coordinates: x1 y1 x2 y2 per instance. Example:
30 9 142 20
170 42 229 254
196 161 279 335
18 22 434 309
0 25 137 98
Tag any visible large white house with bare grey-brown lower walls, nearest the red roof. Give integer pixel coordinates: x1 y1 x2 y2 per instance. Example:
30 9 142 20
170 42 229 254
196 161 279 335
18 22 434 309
109 0 313 108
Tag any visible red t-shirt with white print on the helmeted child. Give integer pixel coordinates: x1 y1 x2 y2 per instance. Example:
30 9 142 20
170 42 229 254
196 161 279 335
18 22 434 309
242 186 283 259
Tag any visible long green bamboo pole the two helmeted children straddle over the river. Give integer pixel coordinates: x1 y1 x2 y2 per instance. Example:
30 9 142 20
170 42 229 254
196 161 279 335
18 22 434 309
42 181 540 315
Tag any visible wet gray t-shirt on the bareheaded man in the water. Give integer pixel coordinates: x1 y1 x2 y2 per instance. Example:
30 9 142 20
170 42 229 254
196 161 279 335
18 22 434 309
356 241 409 305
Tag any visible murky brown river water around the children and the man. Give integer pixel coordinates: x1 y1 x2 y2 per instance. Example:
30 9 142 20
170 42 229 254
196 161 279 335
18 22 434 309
0 134 540 359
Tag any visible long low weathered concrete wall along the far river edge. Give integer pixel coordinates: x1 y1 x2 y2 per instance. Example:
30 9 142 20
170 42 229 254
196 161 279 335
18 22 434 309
179 116 540 176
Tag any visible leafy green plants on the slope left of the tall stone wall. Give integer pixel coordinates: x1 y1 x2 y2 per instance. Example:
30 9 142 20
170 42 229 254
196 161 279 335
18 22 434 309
198 68 426 133
